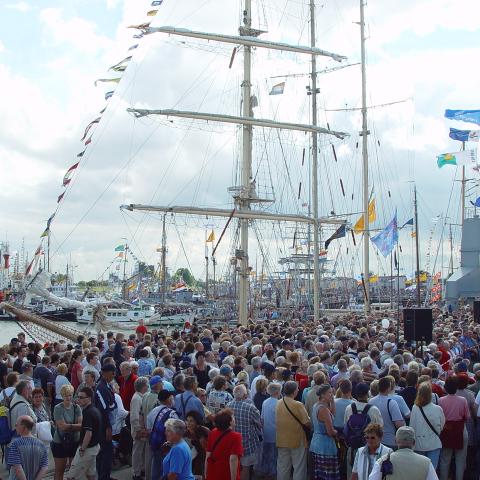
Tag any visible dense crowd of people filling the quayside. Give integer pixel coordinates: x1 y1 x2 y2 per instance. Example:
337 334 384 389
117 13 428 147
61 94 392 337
0 309 480 480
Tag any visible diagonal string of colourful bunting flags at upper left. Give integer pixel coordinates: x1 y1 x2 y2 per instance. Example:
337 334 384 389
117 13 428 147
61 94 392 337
25 0 169 275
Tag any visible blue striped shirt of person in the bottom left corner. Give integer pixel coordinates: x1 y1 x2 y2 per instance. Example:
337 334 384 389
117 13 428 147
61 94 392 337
7 437 48 480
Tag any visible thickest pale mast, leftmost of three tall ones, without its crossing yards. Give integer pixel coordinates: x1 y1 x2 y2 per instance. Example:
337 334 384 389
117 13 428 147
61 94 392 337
238 0 252 325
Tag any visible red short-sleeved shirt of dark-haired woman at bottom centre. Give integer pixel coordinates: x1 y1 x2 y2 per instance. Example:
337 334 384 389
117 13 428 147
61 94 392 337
206 428 243 480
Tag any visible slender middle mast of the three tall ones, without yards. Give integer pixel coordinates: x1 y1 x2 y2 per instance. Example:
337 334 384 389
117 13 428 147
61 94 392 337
310 0 320 321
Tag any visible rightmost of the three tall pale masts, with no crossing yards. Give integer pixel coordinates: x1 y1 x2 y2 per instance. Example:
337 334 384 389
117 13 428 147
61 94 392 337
360 0 370 313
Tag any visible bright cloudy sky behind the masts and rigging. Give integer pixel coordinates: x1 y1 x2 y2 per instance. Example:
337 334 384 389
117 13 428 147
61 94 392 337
0 0 480 279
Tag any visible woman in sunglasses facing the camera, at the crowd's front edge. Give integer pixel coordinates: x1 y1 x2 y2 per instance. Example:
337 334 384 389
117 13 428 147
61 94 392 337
351 423 393 480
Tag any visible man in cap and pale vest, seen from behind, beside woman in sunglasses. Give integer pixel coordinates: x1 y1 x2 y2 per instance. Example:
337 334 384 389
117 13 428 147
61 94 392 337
368 427 438 480
